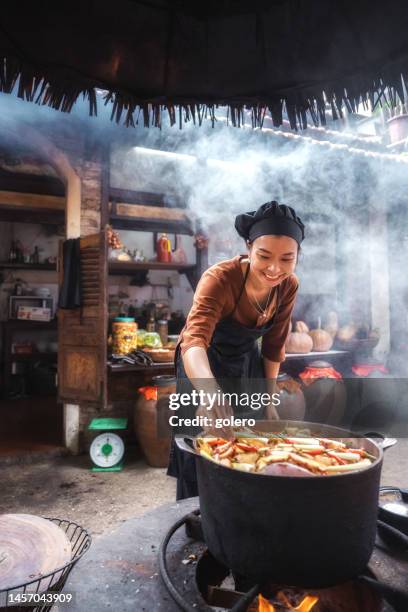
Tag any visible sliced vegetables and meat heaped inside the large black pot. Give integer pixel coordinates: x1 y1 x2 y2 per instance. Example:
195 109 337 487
196 433 376 476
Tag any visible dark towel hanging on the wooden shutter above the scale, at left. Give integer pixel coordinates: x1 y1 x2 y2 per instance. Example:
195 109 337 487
58 238 82 309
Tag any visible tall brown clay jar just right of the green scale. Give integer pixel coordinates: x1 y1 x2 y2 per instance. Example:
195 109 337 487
134 376 176 468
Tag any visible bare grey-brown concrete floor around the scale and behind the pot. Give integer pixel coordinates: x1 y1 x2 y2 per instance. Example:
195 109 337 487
0 439 408 537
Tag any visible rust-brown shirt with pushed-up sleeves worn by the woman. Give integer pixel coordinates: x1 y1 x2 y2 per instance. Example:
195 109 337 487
180 255 299 362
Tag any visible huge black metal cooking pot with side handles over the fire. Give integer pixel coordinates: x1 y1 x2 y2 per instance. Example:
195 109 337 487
176 421 383 588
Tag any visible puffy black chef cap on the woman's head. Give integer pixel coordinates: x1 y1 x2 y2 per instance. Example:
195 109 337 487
235 201 305 245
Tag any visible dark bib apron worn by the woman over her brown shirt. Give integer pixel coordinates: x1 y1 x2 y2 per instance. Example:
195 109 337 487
167 266 279 500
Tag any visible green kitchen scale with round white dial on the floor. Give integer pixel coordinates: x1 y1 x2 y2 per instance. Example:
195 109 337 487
88 418 127 472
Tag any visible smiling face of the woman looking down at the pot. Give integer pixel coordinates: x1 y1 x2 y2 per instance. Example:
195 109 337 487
248 235 298 287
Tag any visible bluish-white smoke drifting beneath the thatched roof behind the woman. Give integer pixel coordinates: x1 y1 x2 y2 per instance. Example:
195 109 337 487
0 89 408 368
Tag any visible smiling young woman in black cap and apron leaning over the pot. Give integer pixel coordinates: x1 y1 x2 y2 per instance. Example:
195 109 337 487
168 201 304 499
